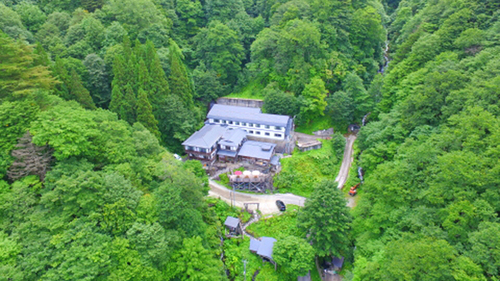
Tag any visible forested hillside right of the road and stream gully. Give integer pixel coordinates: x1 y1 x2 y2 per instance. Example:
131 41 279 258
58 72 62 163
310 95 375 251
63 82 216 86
353 0 500 280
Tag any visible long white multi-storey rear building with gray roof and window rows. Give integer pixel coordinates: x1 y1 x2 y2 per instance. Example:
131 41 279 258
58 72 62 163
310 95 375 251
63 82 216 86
207 104 293 140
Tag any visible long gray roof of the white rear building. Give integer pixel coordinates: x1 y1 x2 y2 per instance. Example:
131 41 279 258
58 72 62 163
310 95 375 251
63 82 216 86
207 104 290 127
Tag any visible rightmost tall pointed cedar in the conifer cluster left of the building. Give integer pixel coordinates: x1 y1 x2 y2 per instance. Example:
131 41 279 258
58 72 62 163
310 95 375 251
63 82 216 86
169 40 193 108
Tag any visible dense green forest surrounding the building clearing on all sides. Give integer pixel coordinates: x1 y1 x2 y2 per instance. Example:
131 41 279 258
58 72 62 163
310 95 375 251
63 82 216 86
0 0 500 281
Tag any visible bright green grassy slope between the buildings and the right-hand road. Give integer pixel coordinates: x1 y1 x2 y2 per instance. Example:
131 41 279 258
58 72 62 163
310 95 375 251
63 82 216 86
274 140 343 197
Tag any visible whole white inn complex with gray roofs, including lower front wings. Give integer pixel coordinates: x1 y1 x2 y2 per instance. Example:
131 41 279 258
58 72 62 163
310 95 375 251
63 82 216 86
182 104 293 165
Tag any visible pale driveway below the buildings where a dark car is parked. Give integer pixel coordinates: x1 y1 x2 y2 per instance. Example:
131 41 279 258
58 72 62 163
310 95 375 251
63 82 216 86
208 180 306 215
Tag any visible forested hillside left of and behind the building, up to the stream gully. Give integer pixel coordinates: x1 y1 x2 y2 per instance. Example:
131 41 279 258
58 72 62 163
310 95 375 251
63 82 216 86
0 0 388 280
